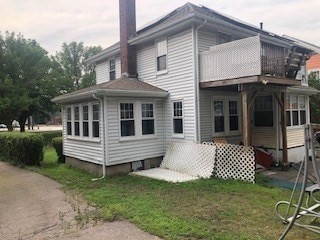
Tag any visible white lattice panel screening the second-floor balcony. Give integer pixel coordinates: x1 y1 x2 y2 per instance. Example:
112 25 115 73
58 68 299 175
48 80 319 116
200 36 261 82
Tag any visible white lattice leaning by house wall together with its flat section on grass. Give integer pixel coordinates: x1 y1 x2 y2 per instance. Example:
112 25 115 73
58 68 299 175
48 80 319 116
132 142 216 182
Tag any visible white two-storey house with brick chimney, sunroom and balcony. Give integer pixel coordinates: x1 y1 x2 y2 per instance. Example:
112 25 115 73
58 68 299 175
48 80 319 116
53 0 317 174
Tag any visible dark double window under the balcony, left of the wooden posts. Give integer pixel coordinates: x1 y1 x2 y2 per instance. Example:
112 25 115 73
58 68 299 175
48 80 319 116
212 98 240 135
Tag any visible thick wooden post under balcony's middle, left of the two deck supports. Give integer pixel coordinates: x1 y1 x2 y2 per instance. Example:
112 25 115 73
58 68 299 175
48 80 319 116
241 89 250 147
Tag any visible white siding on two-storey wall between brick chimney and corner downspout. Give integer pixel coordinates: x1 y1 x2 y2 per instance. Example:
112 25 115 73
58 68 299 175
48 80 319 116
137 29 196 142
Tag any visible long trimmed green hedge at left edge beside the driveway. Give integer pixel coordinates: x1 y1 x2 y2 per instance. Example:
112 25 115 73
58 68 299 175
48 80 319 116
0 133 44 165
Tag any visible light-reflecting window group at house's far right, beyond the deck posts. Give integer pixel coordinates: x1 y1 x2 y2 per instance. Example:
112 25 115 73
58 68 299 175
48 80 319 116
286 95 306 126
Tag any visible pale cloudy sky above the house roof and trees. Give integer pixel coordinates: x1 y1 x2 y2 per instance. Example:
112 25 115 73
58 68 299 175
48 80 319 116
0 0 320 54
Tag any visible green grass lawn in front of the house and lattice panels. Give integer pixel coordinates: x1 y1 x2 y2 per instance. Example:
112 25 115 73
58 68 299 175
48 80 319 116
33 148 319 240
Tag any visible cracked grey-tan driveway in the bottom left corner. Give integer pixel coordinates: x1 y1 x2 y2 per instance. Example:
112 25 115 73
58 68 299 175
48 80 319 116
0 162 160 240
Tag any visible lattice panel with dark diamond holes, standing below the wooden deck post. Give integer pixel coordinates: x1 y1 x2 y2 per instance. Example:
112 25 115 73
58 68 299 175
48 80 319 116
204 143 255 183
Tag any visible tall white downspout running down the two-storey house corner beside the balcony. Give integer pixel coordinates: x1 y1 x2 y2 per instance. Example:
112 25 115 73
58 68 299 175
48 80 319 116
192 19 207 142
